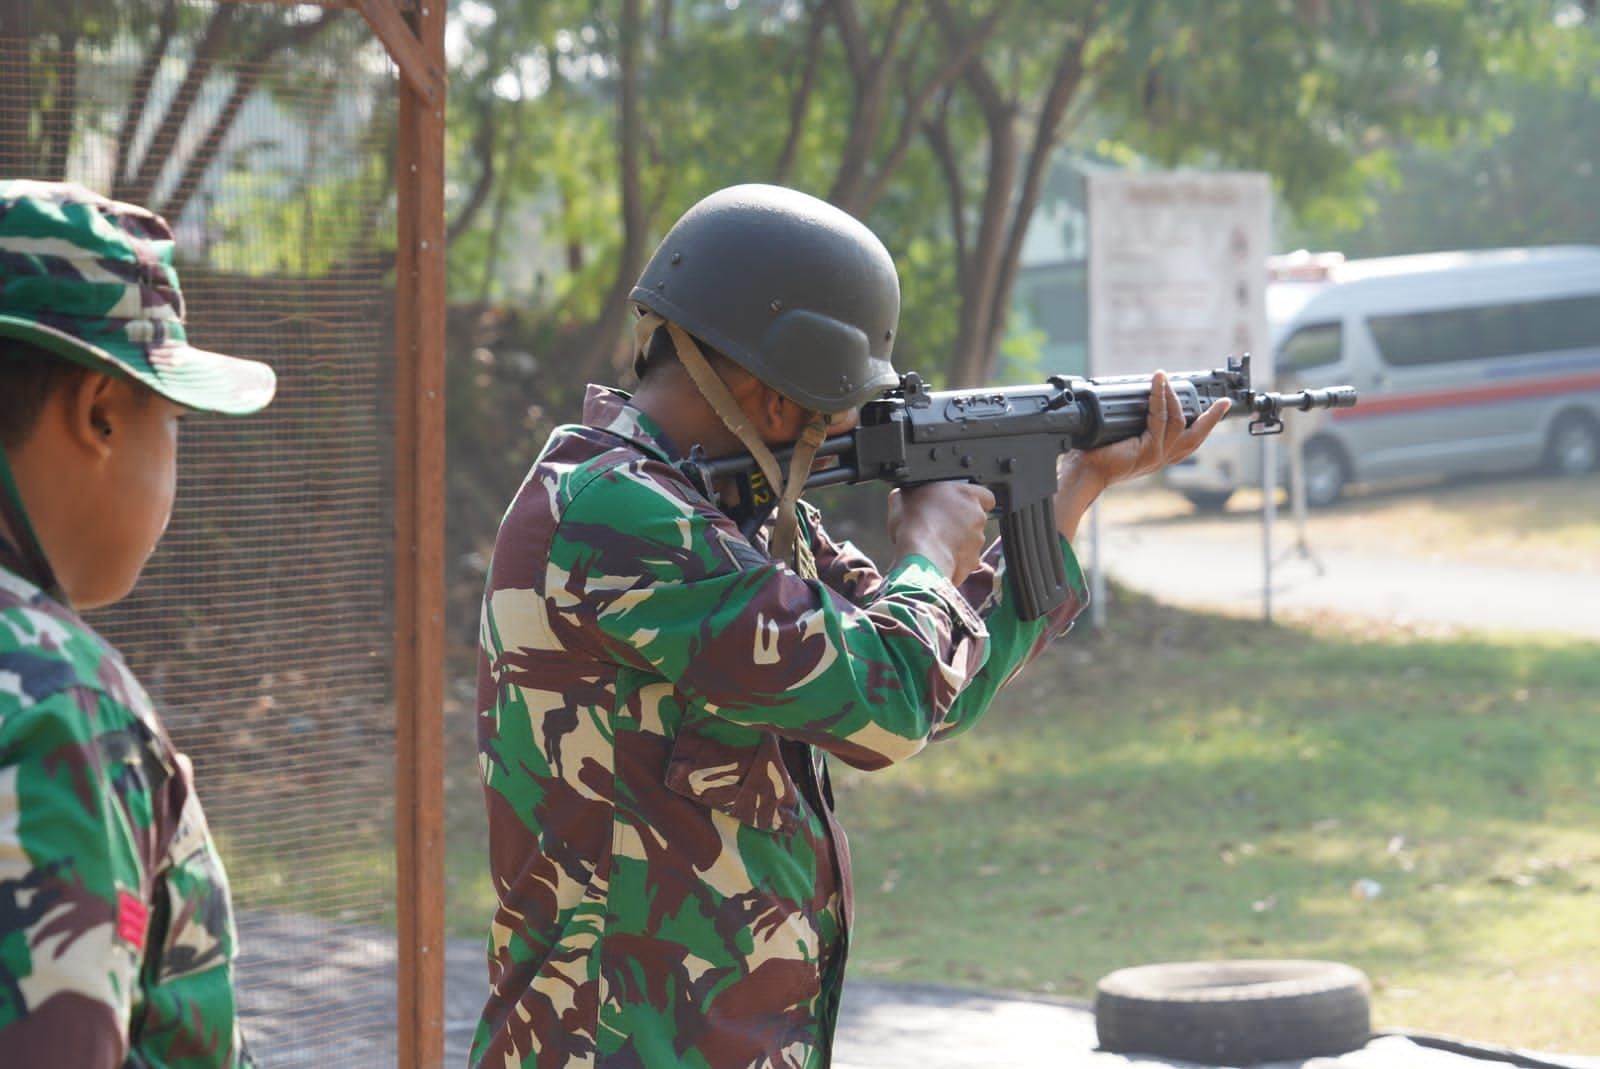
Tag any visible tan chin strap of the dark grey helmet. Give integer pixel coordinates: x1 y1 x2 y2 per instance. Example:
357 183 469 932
634 312 827 579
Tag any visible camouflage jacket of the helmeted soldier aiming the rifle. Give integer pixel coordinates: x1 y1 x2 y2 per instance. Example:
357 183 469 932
472 387 1085 1069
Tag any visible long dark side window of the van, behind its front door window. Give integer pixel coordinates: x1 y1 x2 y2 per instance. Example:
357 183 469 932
1366 294 1600 366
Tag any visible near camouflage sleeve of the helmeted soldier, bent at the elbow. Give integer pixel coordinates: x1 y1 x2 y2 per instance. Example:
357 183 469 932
546 464 1062 768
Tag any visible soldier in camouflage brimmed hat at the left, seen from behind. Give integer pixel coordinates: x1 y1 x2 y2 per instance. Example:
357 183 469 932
0 181 275 1069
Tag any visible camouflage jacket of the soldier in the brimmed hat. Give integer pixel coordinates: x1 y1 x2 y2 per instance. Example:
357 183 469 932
0 539 253 1069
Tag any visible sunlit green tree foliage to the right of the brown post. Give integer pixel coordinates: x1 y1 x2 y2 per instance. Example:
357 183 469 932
438 0 1586 384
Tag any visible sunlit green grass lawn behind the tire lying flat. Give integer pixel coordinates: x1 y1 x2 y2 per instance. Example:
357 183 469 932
837 599 1600 1053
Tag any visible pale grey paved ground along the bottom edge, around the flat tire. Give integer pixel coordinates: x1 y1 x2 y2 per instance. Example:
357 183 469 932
238 912 1600 1069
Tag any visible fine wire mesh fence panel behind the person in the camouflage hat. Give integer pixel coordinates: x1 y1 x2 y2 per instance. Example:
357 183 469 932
0 0 425 1069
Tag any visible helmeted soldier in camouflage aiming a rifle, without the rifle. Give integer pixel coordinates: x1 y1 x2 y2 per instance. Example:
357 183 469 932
472 186 1226 1069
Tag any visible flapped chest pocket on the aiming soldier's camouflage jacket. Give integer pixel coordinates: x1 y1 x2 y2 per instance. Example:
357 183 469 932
666 723 800 832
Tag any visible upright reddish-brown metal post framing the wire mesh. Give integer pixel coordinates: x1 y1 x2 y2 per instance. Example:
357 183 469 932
212 0 445 1069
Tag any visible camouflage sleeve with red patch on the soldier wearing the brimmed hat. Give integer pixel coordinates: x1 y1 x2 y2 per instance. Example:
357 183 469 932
0 688 152 1069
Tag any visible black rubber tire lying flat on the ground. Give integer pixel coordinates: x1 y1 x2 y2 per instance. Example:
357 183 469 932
1094 960 1371 1066
